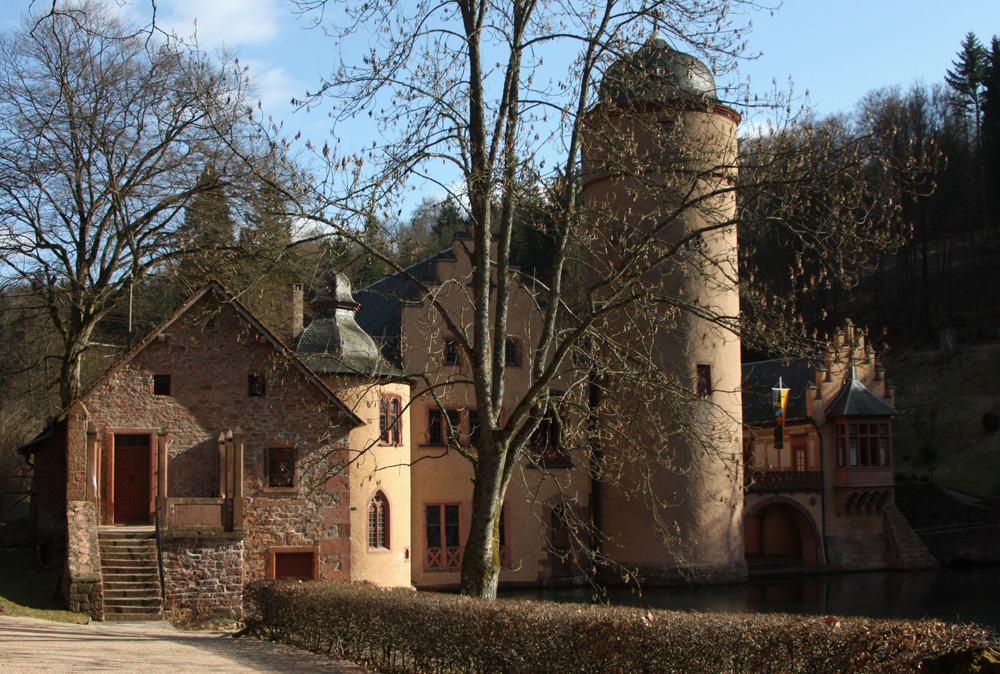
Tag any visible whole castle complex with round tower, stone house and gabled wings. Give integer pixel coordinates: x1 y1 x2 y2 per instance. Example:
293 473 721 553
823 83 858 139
22 38 933 619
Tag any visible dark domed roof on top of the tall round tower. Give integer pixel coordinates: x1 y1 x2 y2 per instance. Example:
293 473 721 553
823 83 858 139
599 34 718 103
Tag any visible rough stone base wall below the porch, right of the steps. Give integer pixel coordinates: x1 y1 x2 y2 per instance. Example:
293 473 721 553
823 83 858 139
163 538 244 619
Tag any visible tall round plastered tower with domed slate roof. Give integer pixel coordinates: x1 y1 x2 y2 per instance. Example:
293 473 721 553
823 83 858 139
583 36 746 584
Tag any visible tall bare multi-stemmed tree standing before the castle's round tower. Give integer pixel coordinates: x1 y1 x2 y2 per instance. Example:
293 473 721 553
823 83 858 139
290 0 920 596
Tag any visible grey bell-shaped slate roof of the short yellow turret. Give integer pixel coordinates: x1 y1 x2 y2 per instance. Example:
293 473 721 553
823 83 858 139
295 268 386 375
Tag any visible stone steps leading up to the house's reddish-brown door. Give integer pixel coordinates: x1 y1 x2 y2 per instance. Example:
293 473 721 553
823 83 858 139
98 530 163 620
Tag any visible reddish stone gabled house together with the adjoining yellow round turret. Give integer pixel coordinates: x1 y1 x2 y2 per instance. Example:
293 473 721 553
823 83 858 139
22 281 410 619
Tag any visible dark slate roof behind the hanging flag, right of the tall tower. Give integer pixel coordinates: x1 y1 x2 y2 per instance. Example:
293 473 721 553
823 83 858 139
743 358 816 426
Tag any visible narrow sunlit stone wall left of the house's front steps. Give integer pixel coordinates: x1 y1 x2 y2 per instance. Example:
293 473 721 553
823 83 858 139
63 501 104 620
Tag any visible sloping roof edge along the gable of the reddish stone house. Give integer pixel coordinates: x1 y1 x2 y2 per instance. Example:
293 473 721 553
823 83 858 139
69 279 364 426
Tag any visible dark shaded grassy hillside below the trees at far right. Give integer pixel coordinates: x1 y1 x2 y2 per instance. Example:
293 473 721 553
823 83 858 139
885 344 1000 496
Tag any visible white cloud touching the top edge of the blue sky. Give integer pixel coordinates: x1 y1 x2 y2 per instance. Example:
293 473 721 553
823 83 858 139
157 0 285 48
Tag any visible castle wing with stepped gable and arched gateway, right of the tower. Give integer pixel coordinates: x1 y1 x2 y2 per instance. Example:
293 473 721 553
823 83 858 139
743 321 936 572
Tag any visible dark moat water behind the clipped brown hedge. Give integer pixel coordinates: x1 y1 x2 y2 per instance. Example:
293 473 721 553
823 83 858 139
501 566 1000 635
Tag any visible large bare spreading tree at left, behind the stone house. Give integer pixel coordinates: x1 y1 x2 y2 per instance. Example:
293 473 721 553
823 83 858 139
0 3 268 405
